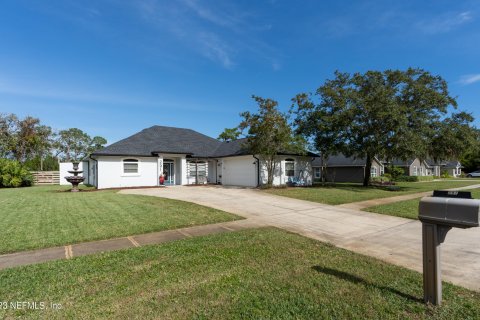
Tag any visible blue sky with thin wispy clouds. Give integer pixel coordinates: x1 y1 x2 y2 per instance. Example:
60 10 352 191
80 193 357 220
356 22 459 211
0 0 480 142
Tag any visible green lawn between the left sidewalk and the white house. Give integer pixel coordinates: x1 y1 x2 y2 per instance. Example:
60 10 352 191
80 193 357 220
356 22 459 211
0 186 239 253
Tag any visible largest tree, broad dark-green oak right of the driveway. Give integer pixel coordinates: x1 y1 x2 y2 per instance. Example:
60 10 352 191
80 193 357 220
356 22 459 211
293 68 473 185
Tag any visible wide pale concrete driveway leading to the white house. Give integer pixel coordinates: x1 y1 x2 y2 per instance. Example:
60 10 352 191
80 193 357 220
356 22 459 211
120 186 480 291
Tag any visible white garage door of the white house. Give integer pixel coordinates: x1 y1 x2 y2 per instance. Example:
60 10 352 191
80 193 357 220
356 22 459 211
222 156 257 187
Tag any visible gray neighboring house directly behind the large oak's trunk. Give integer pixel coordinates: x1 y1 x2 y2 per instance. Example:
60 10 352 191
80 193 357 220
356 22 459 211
312 154 384 182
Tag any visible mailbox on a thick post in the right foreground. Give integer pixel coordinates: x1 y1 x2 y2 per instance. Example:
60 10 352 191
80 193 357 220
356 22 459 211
418 190 480 305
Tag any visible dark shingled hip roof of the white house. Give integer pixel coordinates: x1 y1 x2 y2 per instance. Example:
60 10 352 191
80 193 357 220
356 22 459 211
92 126 316 158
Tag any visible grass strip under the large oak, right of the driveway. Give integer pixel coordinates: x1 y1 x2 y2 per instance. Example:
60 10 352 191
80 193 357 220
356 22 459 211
265 180 480 205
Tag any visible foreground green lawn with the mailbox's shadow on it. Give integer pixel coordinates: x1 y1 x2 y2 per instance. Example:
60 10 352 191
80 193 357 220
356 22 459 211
0 228 480 319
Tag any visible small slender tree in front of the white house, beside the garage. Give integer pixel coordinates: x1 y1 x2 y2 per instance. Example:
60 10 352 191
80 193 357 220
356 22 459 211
239 96 305 187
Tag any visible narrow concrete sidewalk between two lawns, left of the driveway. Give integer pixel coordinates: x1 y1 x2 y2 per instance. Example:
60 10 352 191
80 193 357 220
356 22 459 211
0 219 263 270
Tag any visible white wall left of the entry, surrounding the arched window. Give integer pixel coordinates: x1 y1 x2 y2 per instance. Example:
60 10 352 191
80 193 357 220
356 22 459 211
97 156 158 189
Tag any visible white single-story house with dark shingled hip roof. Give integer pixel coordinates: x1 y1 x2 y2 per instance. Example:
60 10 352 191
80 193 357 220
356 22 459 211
83 126 314 189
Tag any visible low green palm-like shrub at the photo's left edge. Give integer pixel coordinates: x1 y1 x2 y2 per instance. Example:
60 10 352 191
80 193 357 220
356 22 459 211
0 159 33 188
